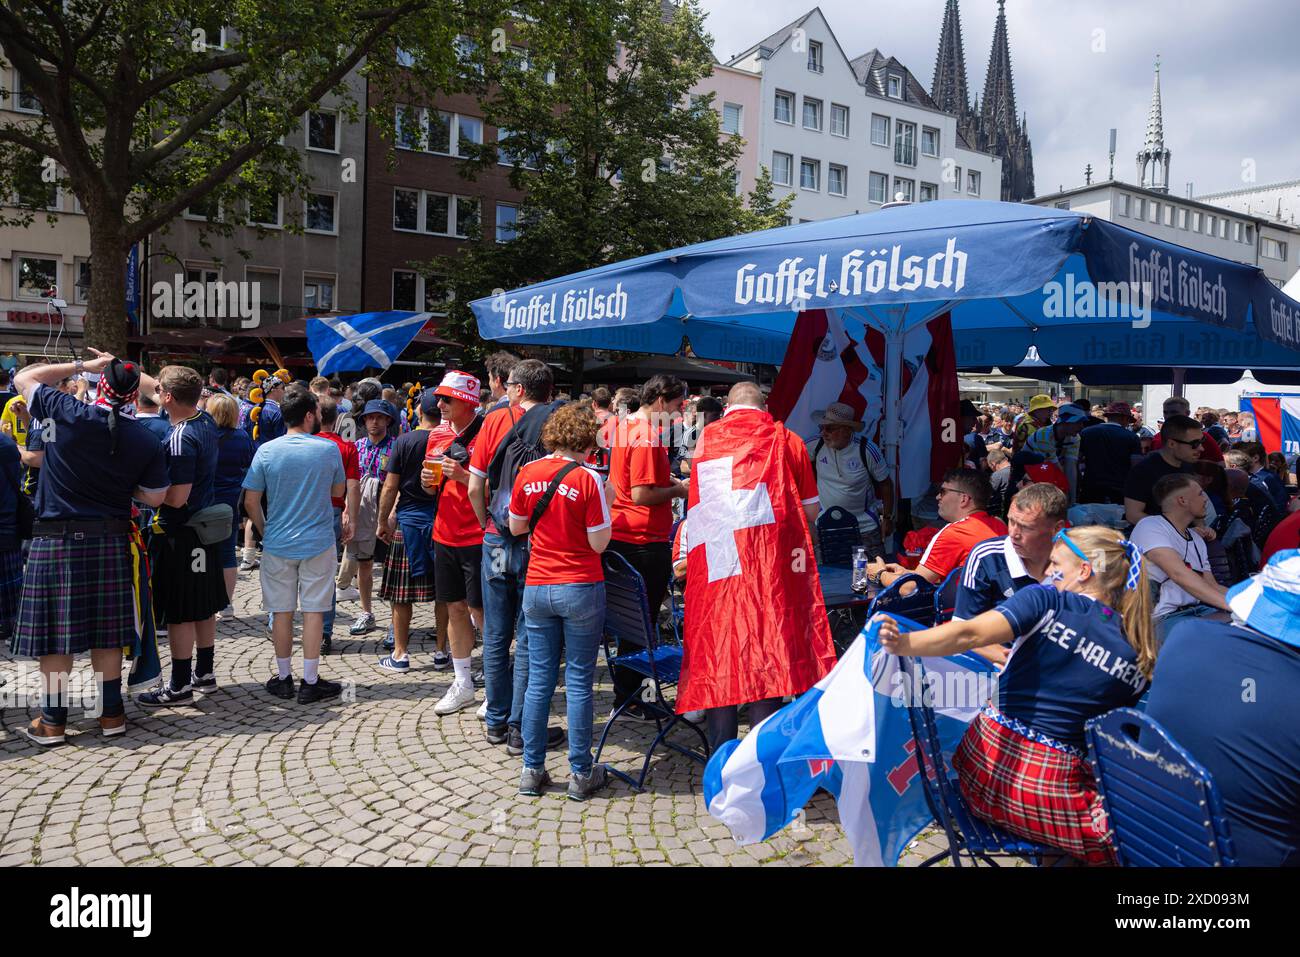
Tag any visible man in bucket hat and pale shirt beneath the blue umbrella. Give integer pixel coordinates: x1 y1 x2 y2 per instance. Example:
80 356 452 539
805 402 893 559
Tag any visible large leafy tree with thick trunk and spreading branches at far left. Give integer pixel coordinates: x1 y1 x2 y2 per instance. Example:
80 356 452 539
0 0 506 351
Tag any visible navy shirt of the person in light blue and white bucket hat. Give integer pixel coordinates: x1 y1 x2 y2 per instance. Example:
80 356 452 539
1147 620 1300 867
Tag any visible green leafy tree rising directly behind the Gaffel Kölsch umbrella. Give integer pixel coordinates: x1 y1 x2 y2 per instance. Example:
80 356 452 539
421 0 790 345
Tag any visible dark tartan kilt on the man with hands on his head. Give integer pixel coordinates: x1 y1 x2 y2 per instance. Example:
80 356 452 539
10 534 135 658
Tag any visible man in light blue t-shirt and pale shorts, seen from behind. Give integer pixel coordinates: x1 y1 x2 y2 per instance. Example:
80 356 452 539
243 389 347 705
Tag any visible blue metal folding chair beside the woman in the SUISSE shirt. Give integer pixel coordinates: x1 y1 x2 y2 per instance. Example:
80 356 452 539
594 551 709 791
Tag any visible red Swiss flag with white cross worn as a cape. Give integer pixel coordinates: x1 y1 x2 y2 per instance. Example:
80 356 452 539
677 408 835 713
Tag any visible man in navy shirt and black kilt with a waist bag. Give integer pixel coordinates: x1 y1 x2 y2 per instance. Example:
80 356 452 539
135 365 230 707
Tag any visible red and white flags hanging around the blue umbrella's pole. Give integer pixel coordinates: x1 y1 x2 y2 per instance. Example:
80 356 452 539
767 309 965 498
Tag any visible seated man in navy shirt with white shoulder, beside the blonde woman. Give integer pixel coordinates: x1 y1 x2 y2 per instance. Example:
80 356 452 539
953 482 1069 631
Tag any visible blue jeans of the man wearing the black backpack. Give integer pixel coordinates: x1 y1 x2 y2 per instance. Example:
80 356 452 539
480 532 528 728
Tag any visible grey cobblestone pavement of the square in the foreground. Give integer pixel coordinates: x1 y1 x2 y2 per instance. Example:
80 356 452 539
0 573 967 866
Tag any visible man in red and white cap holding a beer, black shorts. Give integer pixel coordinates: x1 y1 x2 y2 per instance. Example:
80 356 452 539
421 369 484 715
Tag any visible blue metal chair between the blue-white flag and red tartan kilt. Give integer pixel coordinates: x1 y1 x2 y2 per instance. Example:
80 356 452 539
898 658 1061 867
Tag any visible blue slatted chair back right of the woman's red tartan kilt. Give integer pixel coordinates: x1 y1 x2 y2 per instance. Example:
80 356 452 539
1084 707 1236 867
